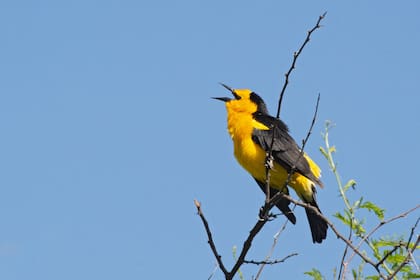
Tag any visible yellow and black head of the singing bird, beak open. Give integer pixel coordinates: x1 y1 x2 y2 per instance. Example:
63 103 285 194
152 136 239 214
213 84 268 114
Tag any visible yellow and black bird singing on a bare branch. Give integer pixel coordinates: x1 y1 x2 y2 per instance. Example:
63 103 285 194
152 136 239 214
214 84 328 243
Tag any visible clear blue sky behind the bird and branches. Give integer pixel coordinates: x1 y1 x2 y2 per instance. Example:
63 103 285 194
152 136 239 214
0 0 420 280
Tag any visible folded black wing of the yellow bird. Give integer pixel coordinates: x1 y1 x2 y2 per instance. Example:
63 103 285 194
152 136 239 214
252 113 322 185
